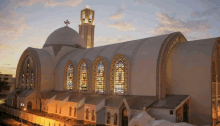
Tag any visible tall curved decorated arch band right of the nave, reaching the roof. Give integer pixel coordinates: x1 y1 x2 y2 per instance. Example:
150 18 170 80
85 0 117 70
156 32 187 99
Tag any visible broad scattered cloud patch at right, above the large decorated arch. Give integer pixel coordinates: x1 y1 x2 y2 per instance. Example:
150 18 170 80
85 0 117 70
149 13 215 40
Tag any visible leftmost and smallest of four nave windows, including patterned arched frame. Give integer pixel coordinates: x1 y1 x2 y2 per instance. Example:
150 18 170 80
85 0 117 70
63 61 75 91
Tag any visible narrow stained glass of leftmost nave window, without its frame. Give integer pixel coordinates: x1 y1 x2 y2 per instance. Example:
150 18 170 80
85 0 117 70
67 64 73 90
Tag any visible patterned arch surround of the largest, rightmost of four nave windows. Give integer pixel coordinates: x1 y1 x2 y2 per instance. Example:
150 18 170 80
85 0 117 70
110 54 129 94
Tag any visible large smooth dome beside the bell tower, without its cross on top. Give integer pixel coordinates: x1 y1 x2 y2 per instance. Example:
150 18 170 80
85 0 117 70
43 26 86 48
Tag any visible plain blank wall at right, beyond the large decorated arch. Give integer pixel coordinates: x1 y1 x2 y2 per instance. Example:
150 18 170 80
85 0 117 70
164 38 216 125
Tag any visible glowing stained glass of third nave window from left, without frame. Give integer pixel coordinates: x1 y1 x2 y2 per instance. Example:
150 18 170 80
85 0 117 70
96 62 104 92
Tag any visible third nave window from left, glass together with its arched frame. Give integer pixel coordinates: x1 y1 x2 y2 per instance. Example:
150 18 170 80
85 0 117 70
92 56 107 93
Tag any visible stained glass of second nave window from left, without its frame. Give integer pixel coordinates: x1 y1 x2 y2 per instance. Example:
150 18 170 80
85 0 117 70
80 63 88 91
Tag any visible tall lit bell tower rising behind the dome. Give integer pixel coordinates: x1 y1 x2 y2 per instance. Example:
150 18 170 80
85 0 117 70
79 5 95 48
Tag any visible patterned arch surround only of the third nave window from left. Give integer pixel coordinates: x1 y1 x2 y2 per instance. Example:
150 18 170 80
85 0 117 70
92 56 107 93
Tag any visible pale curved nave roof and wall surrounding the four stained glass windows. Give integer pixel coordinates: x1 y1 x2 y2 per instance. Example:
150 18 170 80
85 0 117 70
55 32 186 96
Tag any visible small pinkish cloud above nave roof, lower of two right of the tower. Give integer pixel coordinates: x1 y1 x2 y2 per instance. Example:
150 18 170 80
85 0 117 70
107 21 136 31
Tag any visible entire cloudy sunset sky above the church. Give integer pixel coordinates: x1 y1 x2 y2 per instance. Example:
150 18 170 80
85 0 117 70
0 0 220 77
